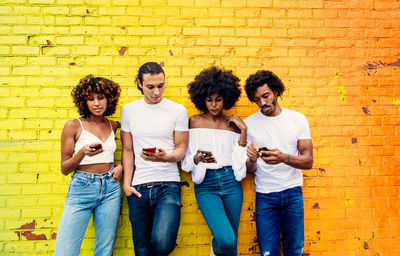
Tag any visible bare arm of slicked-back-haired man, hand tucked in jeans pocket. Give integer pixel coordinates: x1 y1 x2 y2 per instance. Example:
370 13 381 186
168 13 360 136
121 131 142 197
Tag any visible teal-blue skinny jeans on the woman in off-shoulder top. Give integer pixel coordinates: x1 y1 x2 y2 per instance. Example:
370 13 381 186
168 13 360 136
194 166 243 256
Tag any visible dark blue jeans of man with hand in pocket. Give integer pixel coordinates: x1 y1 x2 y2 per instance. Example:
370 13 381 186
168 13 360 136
127 182 181 256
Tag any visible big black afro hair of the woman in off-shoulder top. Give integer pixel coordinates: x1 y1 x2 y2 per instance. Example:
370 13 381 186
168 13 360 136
188 66 241 113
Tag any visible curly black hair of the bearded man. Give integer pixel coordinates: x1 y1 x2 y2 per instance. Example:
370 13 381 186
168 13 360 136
244 70 285 102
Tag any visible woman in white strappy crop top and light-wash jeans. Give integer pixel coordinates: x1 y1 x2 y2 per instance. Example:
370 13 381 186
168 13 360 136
55 75 122 255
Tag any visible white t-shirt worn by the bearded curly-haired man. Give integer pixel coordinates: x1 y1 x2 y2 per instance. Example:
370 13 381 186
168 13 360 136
244 108 311 193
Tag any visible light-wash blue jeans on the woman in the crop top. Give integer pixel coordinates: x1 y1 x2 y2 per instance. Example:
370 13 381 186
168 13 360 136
54 168 121 256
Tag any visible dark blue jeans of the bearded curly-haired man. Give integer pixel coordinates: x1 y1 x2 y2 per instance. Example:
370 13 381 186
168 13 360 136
256 187 304 256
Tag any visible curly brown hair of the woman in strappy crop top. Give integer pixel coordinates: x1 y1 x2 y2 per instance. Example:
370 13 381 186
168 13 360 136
71 75 121 117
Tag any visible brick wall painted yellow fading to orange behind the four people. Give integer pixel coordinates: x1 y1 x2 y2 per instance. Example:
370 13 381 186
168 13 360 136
0 0 400 256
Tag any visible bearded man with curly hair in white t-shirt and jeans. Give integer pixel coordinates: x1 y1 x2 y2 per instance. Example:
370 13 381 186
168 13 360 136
244 70 313 256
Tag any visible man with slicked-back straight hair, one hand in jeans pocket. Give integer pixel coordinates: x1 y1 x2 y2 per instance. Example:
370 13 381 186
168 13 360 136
121 62 188 256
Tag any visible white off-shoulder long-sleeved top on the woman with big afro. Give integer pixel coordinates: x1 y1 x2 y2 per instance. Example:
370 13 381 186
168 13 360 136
182 128 247 184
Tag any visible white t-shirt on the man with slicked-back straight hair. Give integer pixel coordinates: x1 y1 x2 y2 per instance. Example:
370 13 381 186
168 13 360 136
121 98 189 185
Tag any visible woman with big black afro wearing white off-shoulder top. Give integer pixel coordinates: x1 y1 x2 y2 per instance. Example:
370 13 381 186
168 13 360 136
182 67 247 255
